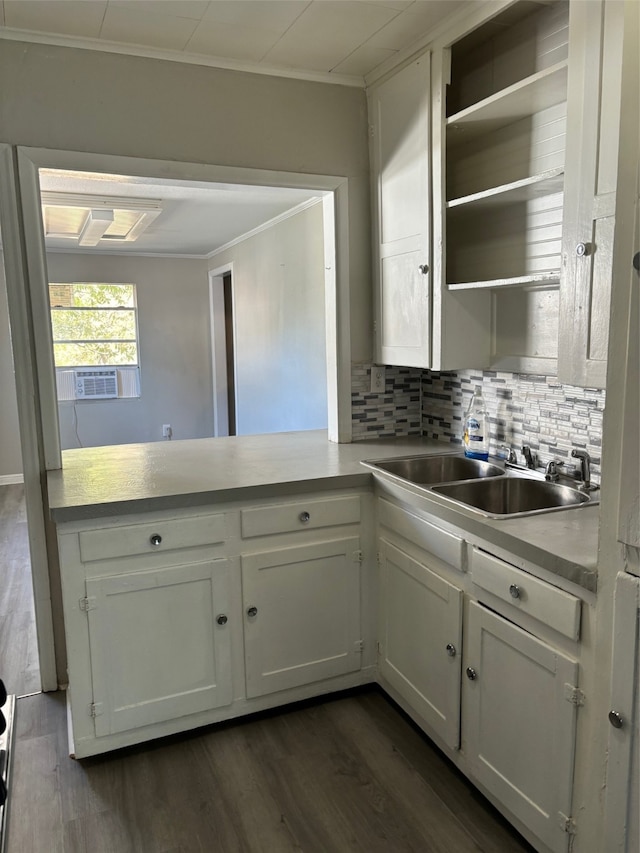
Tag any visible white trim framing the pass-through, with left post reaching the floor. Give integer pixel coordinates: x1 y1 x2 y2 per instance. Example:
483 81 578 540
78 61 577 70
0 144 351 690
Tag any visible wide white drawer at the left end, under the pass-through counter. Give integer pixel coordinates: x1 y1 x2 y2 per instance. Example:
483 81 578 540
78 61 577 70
78 513 226 563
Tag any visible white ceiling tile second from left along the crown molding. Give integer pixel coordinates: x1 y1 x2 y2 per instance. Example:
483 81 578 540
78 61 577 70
100 4 197 50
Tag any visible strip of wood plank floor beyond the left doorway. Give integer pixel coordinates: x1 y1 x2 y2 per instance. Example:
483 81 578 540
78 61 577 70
0 484 41 696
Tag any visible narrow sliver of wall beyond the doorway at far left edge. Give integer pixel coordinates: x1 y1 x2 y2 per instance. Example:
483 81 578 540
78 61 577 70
0 252 22 484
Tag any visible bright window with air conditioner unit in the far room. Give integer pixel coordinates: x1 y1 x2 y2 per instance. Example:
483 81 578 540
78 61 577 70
49 282 139 400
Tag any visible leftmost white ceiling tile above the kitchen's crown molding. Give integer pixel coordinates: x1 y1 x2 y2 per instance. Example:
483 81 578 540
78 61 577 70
4 0 107 38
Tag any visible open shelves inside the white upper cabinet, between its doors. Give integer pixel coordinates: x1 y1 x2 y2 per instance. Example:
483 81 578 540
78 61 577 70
443 0 569 371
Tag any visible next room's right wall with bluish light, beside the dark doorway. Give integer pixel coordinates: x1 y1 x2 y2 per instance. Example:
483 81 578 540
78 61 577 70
209 203 327 435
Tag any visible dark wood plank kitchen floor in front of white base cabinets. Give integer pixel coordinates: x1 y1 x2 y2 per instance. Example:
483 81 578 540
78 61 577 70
7 688 533 853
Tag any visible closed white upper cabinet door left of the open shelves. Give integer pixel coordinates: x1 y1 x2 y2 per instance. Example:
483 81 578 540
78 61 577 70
369 54 431 367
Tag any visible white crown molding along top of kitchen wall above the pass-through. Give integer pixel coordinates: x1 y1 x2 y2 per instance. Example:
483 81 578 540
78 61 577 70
0 27 365 89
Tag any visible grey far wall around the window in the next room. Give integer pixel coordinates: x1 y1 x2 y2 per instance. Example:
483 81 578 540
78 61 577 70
47 253 213 449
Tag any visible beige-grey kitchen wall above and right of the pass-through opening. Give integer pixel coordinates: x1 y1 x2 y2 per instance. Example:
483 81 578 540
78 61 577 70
0 41 371 362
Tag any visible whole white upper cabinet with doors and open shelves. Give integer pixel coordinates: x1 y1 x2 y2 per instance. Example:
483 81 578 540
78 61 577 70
369 0 622 386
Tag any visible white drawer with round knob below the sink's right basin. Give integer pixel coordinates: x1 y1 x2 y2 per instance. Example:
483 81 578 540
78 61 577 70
472 548 580 640
